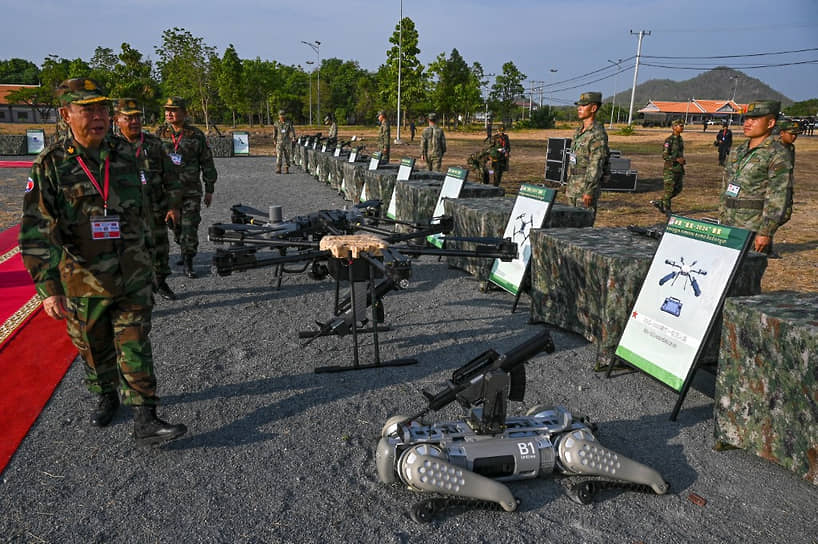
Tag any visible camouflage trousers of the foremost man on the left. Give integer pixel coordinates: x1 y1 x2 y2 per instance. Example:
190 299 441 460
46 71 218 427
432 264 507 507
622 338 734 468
66 292 159 406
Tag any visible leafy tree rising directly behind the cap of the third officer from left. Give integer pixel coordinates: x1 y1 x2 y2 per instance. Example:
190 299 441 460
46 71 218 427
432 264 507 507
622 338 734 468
156 27 215 130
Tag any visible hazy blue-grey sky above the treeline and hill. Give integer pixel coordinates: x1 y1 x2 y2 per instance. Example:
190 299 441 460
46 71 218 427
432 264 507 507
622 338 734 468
0 0 818 103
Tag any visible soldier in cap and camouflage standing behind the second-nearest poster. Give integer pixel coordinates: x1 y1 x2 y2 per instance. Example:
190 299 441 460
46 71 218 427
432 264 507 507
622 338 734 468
565 92 608 223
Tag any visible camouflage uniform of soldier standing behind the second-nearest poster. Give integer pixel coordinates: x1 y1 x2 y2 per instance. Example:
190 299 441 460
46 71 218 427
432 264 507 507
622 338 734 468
565 121 608 217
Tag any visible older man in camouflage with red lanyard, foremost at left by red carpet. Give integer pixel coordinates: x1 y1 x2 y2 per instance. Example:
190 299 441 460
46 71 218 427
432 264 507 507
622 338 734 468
20 78 187 444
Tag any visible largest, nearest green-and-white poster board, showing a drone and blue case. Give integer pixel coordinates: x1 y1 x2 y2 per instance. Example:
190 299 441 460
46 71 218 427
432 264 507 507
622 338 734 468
616 215 751 391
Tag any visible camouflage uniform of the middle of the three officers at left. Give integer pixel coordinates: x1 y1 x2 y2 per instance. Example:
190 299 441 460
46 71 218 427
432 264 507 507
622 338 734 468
131 133 182 283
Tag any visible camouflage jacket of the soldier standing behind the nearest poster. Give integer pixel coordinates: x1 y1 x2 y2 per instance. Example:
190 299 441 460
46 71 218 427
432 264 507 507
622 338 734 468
719 136 792 236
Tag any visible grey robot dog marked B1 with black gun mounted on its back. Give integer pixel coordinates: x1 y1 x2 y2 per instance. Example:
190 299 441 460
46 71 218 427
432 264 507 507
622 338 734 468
375 331 670 521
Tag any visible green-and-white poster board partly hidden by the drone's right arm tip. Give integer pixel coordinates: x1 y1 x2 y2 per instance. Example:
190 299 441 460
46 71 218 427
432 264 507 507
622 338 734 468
489 184 557 295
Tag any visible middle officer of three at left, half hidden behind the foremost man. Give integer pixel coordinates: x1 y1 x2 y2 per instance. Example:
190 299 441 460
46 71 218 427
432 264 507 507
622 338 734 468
114 98 182 300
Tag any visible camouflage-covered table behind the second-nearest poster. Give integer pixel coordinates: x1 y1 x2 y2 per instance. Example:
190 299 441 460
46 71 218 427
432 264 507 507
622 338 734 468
443 197 594 281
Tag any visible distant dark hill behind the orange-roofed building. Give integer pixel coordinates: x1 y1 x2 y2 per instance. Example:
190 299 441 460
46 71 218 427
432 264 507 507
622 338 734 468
605 66 792 111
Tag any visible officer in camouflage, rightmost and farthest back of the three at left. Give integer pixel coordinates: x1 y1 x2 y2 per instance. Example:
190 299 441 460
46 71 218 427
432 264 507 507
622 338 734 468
157 96 218 278
